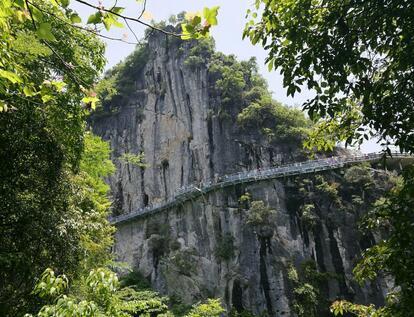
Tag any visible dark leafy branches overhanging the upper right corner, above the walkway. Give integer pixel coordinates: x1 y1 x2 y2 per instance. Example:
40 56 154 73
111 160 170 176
244 0 414 151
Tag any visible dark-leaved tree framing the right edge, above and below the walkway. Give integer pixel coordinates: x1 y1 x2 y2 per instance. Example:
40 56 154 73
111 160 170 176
244 0 414 316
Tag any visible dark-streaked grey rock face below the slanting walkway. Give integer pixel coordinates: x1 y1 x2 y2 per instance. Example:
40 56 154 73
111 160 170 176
115 181 384 316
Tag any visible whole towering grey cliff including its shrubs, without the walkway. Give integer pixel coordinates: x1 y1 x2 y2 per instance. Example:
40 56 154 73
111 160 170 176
91 30 394 316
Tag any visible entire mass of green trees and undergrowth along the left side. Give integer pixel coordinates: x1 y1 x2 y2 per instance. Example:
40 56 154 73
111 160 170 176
0 0 223 316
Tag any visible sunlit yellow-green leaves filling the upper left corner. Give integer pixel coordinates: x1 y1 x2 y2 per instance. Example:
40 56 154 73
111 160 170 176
0 0 104 111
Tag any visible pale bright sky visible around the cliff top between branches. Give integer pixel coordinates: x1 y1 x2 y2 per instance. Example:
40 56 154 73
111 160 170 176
72 0 380 152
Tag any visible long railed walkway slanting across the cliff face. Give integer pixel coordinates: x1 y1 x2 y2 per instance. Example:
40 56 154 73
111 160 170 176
109 153 412 224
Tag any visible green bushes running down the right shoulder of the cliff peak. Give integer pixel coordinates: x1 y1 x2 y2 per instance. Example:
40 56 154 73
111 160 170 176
185 38 311 146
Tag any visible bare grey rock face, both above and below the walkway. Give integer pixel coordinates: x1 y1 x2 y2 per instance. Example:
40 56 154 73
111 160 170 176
92 30 385 316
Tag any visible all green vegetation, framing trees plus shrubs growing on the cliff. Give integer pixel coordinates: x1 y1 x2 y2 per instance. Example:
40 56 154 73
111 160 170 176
0 0 414 317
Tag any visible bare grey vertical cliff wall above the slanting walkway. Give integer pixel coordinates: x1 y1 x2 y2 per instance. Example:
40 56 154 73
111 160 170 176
93 30 308 212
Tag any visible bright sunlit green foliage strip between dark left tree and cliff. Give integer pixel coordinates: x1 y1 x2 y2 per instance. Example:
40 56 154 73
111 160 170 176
71 132 115 274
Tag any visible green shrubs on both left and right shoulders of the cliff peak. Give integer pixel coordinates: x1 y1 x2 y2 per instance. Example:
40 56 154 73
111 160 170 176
97 33 311 147
